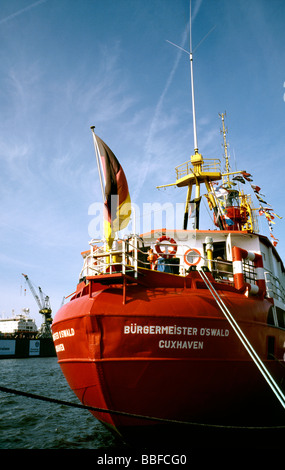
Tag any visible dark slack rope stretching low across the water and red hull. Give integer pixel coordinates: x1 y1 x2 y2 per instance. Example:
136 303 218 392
0 386 285 430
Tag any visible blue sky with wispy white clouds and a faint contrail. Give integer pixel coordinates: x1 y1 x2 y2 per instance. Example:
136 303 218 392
0 0 285 324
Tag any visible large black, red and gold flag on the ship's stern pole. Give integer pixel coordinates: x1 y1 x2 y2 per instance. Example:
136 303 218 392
95 135 131 248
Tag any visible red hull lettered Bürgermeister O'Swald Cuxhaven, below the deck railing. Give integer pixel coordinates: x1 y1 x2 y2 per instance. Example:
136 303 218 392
52 270 285 443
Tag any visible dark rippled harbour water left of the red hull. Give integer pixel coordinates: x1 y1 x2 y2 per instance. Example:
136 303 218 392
0 357 124 451
